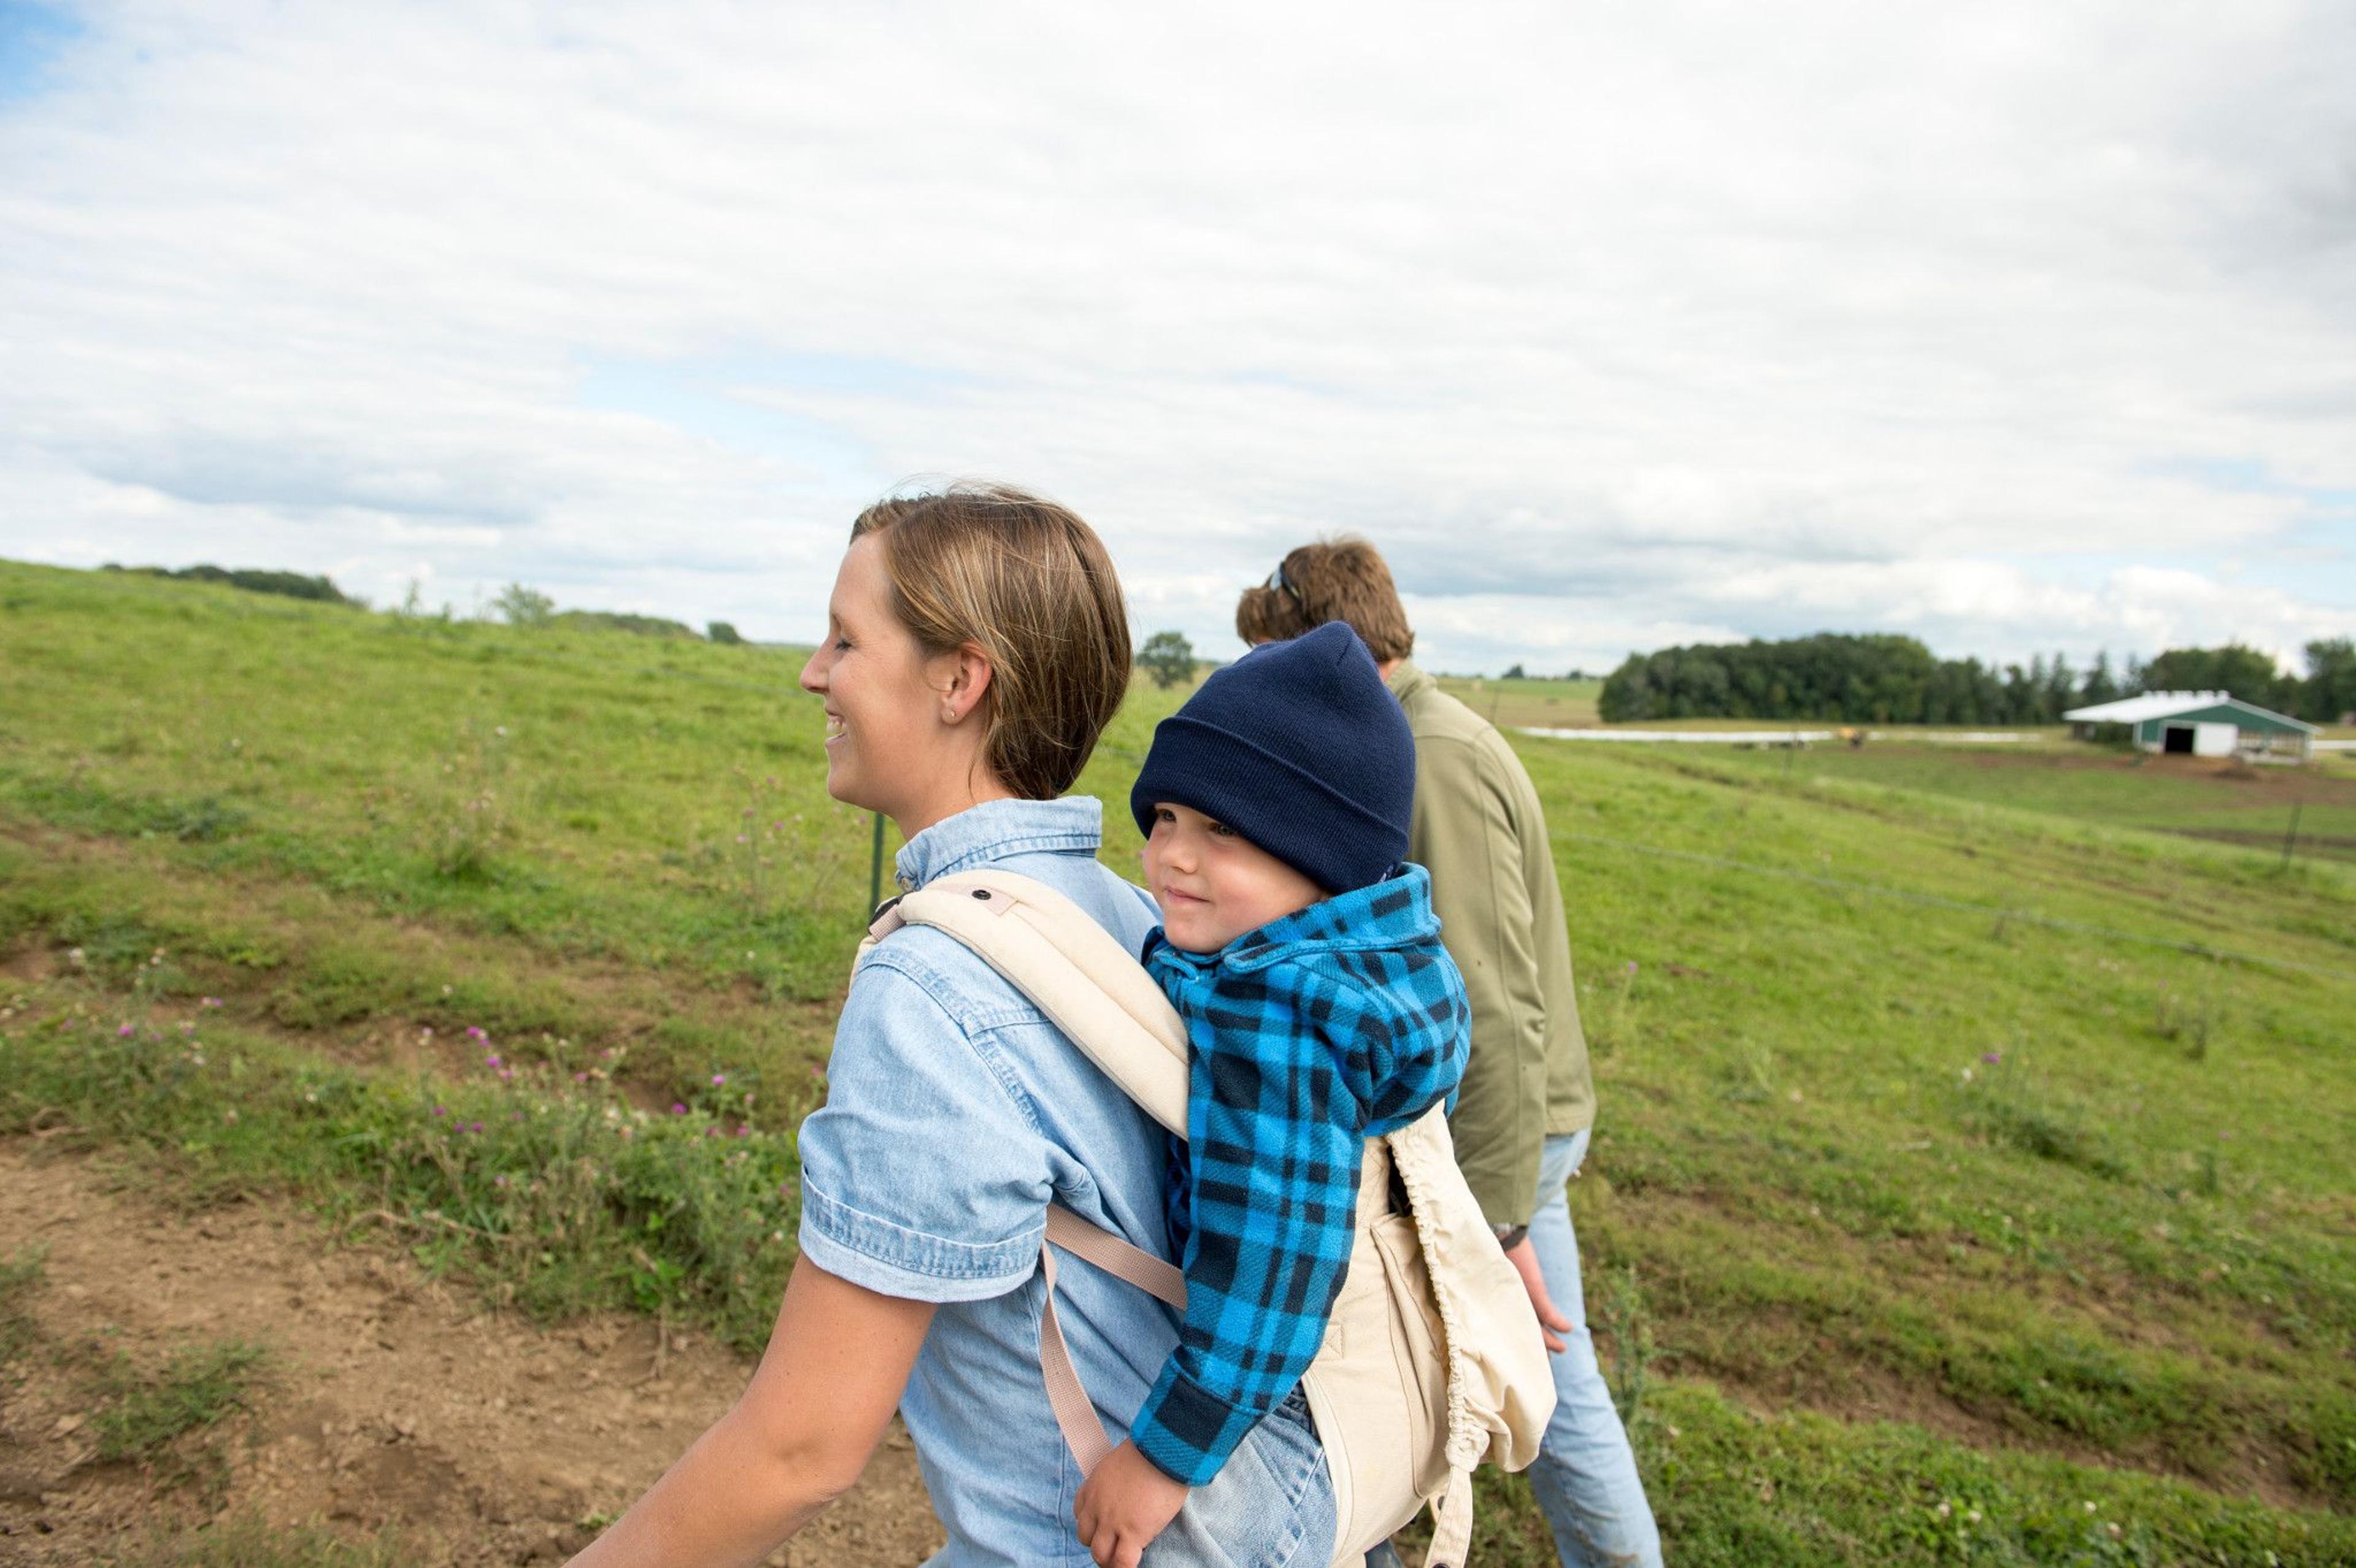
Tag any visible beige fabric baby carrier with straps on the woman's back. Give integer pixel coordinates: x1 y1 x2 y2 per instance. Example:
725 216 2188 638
860 871 1555 1568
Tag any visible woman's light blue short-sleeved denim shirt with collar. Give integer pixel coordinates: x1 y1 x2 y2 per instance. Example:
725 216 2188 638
801 796 1333 1568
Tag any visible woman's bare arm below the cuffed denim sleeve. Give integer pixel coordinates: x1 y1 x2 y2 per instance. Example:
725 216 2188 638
572 1259 933 1568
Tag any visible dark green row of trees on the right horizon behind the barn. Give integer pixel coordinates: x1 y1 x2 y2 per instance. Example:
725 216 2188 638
1598 633 2356 725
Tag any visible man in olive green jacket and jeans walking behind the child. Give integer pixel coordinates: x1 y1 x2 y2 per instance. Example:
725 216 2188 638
1234 539 1661 1568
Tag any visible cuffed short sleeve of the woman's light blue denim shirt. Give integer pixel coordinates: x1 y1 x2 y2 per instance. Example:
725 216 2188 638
801 951 1051 1302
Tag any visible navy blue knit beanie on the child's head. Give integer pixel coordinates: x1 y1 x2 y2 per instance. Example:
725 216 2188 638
1128 621 1416 894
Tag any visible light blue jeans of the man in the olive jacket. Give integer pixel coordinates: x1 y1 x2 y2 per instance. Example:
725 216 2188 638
1366 1132 1661 1568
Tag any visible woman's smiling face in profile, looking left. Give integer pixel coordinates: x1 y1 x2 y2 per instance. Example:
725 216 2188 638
801 534 954 831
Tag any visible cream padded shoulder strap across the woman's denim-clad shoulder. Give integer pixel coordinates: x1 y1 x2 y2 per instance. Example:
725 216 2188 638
860 871 1187 1137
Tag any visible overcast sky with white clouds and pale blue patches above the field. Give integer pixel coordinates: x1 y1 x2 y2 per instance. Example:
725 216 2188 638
0 0 2356 671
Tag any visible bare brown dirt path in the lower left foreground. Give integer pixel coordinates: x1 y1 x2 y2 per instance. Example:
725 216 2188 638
0 1140 942 1568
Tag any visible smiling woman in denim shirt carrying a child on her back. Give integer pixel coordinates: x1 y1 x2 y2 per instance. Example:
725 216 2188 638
575 487 1333 1568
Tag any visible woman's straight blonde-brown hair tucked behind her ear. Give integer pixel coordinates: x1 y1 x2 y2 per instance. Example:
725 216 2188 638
850 485 1128 801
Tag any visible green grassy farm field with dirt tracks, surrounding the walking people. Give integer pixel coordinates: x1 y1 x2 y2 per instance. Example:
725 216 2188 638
0 563 2356 1566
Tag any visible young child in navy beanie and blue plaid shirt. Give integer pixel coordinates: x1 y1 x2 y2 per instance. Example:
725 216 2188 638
1074 621 1470 1563
